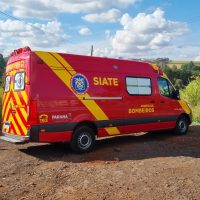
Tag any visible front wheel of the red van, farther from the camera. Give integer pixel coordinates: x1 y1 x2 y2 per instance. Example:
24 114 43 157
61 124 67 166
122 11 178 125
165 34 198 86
174 115 189 135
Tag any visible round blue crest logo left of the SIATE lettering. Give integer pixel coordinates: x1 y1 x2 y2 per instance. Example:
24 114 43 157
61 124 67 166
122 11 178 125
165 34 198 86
71 74 89 94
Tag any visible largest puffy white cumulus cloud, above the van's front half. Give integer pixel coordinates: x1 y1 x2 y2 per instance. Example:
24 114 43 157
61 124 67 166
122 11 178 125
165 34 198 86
111 8 188 54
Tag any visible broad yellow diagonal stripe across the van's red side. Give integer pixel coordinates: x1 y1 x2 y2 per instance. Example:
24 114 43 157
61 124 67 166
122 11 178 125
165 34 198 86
35 51 120 135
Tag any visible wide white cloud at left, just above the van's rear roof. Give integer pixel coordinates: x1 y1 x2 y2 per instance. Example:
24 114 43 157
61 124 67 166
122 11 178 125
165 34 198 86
0 20 67 53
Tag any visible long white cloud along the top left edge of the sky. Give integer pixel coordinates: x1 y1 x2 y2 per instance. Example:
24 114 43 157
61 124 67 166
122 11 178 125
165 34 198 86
1 0 141 18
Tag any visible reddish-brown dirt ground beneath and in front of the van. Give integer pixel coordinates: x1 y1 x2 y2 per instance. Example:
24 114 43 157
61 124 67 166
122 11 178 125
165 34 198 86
0 126 200 200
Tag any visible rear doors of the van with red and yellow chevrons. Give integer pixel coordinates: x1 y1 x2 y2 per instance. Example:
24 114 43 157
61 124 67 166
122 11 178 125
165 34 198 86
2 56 29 137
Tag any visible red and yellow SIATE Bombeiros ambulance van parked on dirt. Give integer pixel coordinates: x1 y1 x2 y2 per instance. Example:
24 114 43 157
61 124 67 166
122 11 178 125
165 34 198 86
1 47 191 152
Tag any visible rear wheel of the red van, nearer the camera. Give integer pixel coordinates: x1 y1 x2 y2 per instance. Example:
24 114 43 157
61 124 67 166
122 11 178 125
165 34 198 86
70 126 95 153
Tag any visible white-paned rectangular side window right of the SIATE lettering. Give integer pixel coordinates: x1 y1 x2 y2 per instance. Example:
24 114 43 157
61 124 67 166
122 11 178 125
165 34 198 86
126 77 151 95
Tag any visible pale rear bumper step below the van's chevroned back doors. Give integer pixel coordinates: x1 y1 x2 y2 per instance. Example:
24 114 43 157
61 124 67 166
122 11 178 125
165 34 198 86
0 132 29 144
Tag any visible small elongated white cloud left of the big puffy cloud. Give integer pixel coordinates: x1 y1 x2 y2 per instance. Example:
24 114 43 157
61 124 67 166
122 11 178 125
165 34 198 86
82 8 121 23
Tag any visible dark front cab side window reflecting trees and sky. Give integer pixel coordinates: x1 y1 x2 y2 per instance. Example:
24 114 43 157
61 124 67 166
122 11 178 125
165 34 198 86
158 77 175 97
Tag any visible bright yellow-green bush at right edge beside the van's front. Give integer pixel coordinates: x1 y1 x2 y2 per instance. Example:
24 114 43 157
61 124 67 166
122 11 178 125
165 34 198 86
181 76 200 122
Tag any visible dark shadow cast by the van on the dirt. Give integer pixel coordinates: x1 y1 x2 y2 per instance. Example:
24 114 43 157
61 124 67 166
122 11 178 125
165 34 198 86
20 126 200 163
